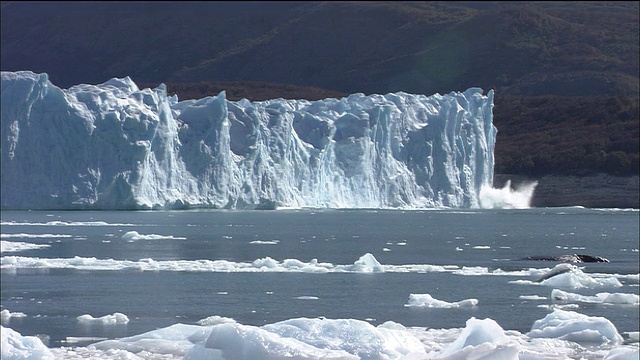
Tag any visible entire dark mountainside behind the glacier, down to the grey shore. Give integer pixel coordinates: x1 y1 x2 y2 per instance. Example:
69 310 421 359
0 1 640 176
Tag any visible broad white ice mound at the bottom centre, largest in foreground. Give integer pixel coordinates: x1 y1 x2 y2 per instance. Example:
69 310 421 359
185 318 426 360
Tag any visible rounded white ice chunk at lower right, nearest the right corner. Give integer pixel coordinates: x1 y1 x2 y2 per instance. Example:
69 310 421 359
527 309 623 344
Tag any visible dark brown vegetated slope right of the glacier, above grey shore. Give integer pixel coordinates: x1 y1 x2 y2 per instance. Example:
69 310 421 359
494 96 640 176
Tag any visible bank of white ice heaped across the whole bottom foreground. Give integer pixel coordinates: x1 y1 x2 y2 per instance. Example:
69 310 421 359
2 310 638 360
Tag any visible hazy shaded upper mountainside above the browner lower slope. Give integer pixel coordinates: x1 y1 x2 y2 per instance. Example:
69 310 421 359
1 1 639 96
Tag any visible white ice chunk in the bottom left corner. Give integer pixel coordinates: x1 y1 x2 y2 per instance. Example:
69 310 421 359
0 326 55 360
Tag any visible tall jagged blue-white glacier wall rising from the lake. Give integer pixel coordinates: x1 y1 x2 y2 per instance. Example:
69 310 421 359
1 71 497 209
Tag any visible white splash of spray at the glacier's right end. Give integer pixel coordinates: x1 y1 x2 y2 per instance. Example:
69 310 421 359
480 180 538 209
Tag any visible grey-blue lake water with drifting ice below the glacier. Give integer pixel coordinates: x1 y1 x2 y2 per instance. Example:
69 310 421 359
1 208 640 358
